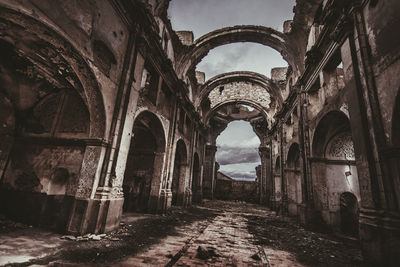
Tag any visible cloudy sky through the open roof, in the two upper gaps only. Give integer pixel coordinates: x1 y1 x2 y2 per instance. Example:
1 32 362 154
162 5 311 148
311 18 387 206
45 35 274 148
168 0 295 79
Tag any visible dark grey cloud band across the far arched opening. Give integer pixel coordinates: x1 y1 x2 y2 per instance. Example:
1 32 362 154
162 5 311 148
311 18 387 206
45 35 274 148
217 146 260 165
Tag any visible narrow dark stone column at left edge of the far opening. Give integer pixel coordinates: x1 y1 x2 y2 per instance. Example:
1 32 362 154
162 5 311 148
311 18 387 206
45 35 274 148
203 145 217 199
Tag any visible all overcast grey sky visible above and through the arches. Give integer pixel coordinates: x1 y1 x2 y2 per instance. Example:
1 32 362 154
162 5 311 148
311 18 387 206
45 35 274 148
168 0 295 179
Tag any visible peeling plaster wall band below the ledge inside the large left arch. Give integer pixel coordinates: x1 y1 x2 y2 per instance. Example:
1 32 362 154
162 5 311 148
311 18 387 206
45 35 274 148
3 144 84 196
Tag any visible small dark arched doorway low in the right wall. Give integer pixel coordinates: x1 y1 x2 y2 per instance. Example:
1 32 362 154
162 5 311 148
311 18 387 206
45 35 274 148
340 192 359 237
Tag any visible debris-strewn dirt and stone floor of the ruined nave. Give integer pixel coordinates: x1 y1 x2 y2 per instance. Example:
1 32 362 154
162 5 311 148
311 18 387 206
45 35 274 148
0 201 362 266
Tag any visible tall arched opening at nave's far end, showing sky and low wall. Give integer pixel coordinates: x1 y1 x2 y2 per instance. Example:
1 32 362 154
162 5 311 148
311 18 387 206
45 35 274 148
215 120 265 202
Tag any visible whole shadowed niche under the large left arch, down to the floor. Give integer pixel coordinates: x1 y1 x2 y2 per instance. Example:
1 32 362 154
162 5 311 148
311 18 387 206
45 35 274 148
1 89 90 231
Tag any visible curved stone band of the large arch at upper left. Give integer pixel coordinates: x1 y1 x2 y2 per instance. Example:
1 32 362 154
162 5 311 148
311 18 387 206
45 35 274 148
0 7 105 138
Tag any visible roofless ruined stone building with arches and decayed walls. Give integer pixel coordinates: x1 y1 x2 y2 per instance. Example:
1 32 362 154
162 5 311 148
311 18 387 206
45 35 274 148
0 0 400 265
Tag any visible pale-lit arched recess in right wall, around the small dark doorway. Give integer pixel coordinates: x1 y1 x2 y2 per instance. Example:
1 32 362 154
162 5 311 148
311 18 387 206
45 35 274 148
311 111 360 233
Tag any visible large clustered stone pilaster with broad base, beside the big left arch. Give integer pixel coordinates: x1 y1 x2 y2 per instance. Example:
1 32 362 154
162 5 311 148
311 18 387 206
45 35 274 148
68 28 144 234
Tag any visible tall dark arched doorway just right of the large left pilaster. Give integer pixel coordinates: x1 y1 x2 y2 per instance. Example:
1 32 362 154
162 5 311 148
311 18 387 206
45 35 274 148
123 111 165 212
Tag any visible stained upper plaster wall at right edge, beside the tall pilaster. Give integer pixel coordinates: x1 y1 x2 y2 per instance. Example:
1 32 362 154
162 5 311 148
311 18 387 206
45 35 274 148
363 0 400 143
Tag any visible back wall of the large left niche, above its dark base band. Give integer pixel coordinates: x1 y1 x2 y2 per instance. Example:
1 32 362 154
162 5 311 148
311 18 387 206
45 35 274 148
3 90 90 196
